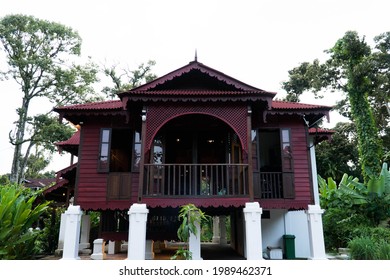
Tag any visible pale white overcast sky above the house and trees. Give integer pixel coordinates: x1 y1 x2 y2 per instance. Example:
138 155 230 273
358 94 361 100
0 0 390 175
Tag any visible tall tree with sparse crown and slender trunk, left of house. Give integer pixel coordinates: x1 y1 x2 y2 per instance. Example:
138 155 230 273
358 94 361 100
0 15 100 183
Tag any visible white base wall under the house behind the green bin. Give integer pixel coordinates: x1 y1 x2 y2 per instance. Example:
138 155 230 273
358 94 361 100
261 209 310 258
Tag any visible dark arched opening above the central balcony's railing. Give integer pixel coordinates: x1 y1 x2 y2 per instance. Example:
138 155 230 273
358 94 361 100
151 114 241 164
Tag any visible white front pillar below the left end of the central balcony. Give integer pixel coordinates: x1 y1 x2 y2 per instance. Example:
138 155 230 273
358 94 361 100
127 203 149 260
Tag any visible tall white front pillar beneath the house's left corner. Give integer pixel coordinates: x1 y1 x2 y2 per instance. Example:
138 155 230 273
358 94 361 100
62 205 83 260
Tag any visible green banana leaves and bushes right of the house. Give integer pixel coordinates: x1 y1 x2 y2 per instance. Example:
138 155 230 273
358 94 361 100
318 163 390 252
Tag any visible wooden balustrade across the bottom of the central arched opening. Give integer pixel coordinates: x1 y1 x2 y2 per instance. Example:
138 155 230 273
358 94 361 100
143 164 248 197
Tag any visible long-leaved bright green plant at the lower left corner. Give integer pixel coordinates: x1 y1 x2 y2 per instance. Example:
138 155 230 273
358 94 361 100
0 185 48 259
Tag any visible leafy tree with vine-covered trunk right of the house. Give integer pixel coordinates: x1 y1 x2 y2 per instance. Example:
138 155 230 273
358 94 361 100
283 31 390 182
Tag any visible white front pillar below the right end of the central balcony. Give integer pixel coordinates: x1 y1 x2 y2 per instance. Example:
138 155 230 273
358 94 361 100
243 202 263 260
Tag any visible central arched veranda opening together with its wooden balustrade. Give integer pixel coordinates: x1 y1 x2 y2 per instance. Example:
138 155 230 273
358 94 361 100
143 114 248 196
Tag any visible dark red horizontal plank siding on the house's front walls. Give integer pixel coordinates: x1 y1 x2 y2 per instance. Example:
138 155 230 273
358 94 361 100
76 115 313 210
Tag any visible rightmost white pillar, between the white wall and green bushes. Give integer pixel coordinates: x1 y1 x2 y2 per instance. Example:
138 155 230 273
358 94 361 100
306 205 327 260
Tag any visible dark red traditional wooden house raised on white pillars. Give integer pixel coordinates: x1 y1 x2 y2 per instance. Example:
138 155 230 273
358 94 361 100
54 59 331 259
